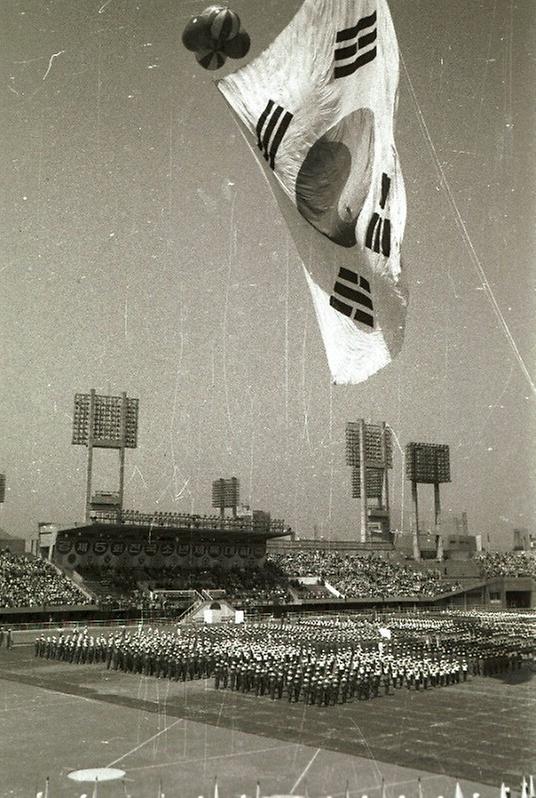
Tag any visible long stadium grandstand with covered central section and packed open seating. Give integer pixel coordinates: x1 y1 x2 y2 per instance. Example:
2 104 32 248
0 524 536 622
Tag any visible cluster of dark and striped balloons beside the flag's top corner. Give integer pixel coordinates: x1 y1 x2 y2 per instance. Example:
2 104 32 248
182 6 250 69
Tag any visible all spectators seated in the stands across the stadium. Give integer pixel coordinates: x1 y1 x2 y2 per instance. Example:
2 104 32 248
0 550 536 609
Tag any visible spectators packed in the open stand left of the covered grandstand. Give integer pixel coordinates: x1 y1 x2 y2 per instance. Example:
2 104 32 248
0 550 88 607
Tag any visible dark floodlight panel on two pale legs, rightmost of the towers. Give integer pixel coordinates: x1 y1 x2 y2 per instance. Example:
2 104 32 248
406 442 450 560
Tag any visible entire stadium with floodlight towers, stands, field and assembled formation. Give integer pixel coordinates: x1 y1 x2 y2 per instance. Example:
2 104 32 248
0 391 536 798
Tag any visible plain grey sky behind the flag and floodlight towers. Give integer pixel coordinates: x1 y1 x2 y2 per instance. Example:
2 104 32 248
0 0 536 546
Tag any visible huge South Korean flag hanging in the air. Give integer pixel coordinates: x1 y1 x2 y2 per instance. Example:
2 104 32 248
217 0 407 383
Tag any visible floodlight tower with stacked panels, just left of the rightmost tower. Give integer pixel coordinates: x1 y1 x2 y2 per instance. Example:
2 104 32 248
346 419 393 543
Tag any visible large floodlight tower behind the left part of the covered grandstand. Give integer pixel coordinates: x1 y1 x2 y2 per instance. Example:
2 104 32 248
72 388 139 522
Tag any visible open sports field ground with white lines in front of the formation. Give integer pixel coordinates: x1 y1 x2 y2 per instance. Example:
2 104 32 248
0 646 536 798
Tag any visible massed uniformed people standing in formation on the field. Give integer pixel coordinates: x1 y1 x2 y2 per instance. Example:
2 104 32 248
35 616 534 706
